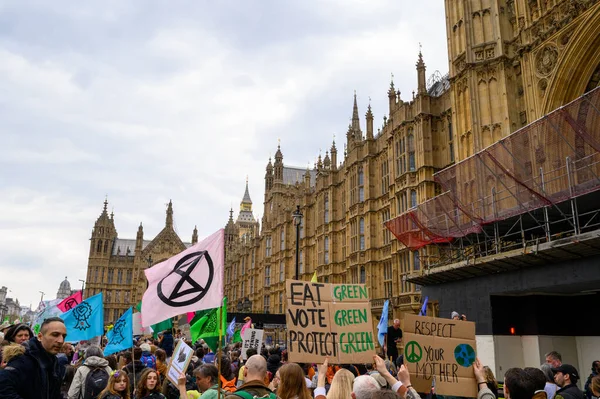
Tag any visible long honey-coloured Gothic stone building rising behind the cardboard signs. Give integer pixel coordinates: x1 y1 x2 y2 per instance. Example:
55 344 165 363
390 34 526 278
225 0 600 344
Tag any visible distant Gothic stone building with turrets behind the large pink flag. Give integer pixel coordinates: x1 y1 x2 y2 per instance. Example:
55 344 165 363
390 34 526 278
84 201 198 324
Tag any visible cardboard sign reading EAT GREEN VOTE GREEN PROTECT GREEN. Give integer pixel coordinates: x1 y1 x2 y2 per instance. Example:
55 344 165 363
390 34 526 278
286 280 376 364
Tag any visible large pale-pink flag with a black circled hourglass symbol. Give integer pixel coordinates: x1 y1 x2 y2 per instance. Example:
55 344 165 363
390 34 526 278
142 229 225 327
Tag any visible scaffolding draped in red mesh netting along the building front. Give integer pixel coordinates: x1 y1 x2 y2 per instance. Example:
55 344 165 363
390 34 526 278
385 87 600 267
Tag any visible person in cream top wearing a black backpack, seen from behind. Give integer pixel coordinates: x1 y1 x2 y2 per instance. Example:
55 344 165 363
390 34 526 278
69 345 112 399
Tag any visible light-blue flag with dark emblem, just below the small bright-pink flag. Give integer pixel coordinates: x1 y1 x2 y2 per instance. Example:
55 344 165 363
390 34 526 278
60 293 104 342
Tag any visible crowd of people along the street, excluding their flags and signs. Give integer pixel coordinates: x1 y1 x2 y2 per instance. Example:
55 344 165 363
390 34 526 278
0 318 600 399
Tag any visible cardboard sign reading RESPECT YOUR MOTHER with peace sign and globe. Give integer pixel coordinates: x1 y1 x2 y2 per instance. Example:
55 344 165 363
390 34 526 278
403 314 477 398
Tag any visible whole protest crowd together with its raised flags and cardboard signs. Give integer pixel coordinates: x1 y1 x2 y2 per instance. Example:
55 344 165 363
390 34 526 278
0 230 600 399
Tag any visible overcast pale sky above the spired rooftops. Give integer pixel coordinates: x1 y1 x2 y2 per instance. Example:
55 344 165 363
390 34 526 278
0 0 448 307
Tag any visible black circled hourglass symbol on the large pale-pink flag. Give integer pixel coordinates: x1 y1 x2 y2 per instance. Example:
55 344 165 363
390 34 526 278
157 251 214 307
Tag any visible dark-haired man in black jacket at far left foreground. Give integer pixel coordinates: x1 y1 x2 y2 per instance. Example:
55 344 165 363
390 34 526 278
0 317 67 399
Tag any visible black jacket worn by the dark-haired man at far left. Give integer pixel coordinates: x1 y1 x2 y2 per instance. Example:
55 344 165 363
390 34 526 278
0 337 64 399
